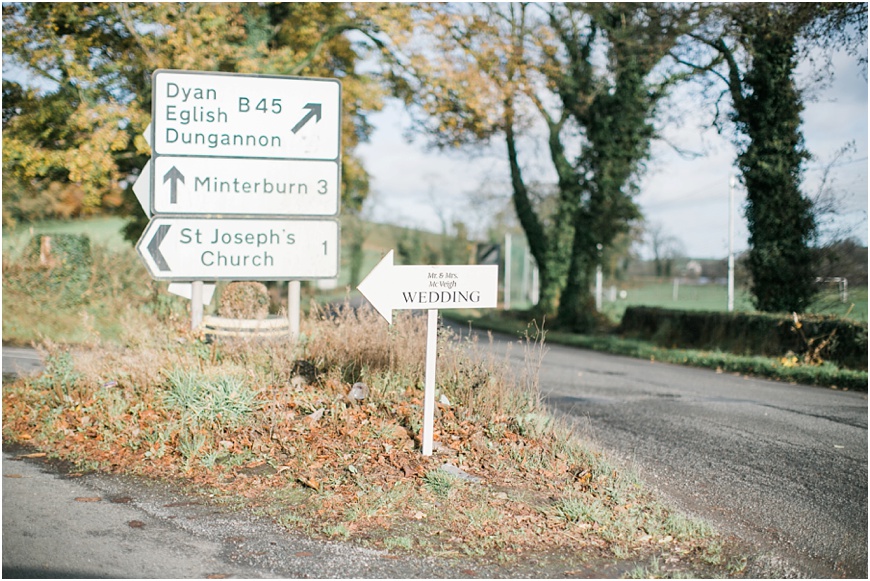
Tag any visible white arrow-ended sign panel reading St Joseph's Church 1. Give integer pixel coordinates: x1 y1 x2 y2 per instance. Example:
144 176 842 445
136 216 340 281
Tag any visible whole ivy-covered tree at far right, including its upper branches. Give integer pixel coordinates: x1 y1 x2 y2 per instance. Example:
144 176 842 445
696 3 867 312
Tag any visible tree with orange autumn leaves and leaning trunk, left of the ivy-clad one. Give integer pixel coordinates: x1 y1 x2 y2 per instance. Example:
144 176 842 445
384 3 570 313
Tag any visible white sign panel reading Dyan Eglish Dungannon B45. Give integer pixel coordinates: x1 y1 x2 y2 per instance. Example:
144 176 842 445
151 70 341 161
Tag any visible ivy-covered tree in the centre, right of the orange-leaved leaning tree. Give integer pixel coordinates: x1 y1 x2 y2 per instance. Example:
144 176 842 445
548 3 696 330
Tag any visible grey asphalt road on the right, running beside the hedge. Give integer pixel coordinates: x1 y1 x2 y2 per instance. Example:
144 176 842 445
500 338 868 578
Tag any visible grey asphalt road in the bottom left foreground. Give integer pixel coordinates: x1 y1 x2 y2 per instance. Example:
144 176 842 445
3 449 516 579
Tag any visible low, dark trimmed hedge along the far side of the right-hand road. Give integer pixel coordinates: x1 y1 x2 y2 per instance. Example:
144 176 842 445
618 307 867 371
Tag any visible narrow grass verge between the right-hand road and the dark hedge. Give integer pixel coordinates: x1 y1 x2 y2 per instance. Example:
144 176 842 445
454 311 868 391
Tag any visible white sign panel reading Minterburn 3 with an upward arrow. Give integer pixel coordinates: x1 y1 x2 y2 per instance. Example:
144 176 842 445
151 155 340 216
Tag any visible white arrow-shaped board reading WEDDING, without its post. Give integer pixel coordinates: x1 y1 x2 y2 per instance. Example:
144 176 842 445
357 250 498 323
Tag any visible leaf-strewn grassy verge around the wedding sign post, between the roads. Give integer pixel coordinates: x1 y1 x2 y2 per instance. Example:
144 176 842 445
3 307 739 576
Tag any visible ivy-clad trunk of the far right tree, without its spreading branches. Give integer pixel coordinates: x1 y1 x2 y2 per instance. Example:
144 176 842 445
729 13 816 312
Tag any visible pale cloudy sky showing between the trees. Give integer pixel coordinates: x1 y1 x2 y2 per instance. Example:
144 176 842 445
358 46 868 259
